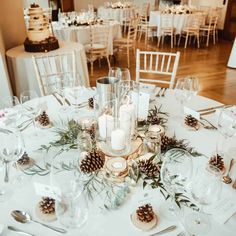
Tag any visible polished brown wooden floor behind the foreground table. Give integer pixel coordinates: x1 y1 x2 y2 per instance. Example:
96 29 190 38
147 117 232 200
89 36 236 104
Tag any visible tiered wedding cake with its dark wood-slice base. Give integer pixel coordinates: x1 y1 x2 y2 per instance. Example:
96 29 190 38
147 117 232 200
24 3 59 52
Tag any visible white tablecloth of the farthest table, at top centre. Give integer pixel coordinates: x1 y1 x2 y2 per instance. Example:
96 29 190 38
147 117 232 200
98 7 136 23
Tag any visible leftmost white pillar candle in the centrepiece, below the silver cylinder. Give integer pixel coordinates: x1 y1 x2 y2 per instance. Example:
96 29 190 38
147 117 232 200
98 114 114 139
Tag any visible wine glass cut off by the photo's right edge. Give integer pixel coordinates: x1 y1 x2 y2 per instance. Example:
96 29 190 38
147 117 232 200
218 106 236 154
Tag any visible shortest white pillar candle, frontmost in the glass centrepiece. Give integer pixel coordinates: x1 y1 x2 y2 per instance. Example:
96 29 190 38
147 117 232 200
111 129 125 151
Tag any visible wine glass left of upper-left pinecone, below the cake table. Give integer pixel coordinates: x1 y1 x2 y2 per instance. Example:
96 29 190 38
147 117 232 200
20 90 41 134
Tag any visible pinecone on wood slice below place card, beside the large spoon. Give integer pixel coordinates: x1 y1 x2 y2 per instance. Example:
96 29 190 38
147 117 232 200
36 197 57 222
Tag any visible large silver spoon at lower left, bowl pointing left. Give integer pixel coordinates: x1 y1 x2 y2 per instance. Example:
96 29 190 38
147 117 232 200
11 210 67 233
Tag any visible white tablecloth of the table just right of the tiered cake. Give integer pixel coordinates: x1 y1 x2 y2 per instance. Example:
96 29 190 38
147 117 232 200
53 21 122 55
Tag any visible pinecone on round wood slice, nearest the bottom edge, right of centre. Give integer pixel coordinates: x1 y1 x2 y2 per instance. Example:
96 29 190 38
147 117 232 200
131 204 157 231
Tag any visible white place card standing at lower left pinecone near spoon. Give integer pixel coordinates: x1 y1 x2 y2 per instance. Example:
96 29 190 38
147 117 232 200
34 182 61 199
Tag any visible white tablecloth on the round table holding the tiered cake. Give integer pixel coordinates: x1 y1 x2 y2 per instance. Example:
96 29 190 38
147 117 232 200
6 41 90 96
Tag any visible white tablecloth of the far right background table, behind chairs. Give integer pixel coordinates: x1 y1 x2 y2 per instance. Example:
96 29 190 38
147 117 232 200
149 11 204 37
